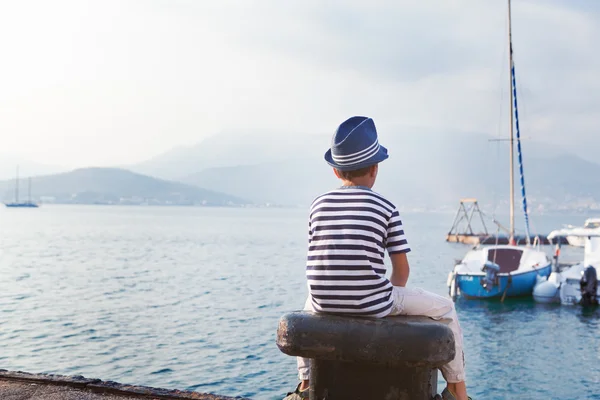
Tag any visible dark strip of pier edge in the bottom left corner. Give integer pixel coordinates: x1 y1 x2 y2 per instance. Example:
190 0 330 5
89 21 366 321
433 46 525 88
0 370 249 400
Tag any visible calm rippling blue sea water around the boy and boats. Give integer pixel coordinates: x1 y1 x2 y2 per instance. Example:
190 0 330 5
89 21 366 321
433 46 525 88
0 206 600 400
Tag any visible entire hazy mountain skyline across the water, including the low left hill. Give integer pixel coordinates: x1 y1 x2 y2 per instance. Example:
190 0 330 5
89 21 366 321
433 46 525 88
0 128 600 213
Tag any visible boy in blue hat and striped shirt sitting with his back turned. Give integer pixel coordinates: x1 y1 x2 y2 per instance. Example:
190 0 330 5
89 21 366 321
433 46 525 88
284 117 469 400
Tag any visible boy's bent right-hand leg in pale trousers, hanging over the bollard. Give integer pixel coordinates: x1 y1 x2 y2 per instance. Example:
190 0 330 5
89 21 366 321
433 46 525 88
390 286 466 386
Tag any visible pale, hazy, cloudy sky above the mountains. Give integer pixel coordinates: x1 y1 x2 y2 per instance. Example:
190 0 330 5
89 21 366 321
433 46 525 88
0 0 600 167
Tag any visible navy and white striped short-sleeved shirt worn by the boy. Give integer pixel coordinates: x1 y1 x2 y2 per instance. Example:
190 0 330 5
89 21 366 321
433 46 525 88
306 186 410 318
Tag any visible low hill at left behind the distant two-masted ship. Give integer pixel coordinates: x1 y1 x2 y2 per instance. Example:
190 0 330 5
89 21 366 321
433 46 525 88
0 168 249 205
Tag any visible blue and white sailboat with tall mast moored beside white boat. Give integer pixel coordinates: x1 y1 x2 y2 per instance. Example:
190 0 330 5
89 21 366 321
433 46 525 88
448 0 552 300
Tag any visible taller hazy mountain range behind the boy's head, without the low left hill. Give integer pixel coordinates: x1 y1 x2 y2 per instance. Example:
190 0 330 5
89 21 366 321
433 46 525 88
131 129 600 211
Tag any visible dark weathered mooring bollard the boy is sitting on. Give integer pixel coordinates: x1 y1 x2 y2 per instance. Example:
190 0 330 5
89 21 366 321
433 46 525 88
277 311 455 400
